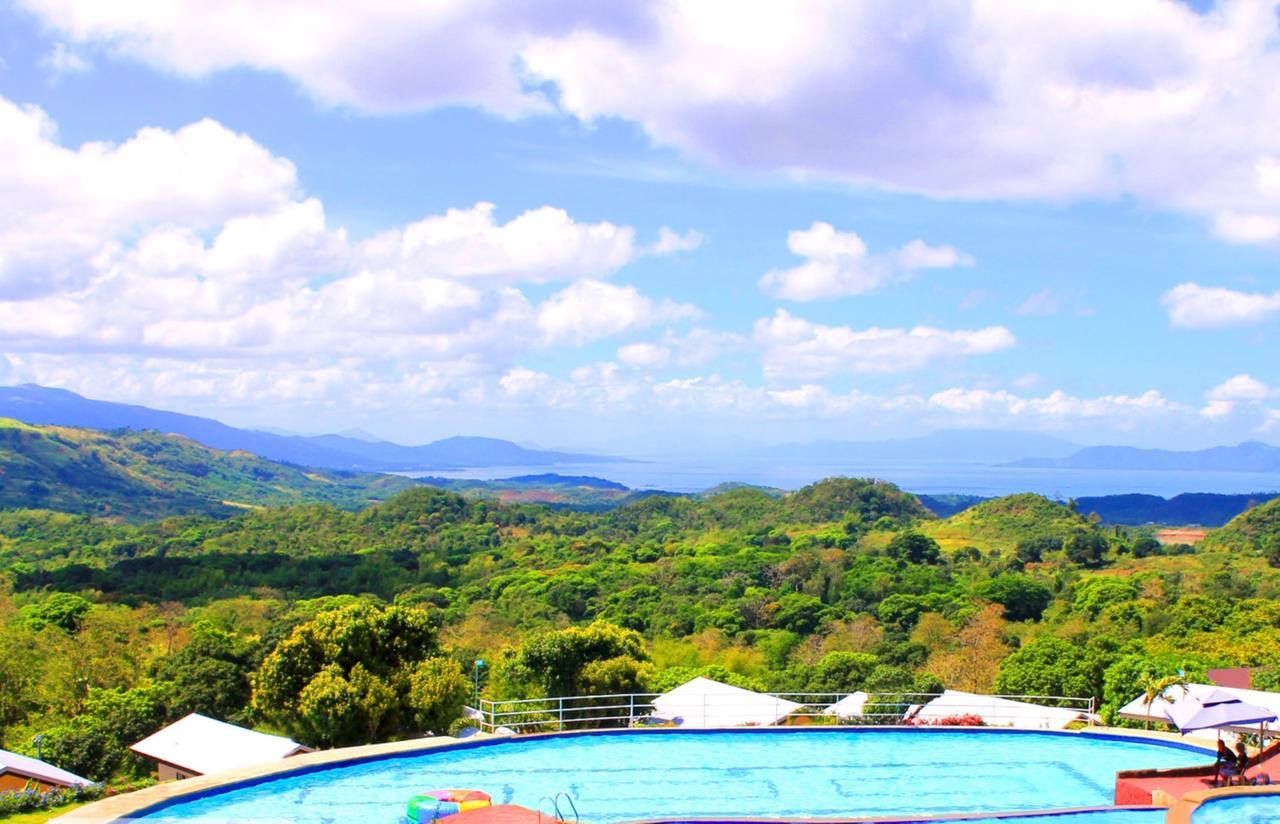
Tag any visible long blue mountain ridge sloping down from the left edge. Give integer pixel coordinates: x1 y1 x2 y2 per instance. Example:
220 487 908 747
0 384 626 472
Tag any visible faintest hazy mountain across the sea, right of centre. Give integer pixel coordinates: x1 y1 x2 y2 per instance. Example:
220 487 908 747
763 429 1080 464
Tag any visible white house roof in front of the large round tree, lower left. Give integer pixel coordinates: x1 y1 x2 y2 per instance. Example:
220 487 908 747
129 713 307 775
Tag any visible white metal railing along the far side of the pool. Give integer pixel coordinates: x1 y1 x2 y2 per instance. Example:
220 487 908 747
472 692 1096 733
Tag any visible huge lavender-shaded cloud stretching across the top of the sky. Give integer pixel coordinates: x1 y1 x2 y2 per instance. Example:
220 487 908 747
19 0 1280 235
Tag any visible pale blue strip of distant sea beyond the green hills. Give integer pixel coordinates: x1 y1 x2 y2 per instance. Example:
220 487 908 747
406 458 1280 499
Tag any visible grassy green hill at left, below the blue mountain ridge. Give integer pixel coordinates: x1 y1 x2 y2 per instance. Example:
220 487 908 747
0 418 413 519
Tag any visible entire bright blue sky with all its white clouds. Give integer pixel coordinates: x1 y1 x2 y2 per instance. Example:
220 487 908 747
0 0 1280 453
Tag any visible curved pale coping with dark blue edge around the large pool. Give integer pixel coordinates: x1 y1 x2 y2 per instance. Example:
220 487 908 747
50 725 1212 824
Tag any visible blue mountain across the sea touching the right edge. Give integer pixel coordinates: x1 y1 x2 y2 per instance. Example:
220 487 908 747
1006 440 1280 473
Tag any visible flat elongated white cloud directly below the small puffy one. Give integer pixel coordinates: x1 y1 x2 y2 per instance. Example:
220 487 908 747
754 308 1016 380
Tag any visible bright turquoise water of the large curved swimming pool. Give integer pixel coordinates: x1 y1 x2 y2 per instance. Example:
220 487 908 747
132 729 1212 824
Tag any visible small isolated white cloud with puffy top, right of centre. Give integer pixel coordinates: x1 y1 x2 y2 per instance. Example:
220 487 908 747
759 221 973 301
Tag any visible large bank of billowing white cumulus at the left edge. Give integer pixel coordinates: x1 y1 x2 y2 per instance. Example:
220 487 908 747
0 93 696 380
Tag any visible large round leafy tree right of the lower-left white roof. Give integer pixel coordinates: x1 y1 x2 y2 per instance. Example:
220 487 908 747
252 604 467 746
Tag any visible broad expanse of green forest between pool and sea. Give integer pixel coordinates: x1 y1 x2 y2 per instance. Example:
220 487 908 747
0 479 1280 778
